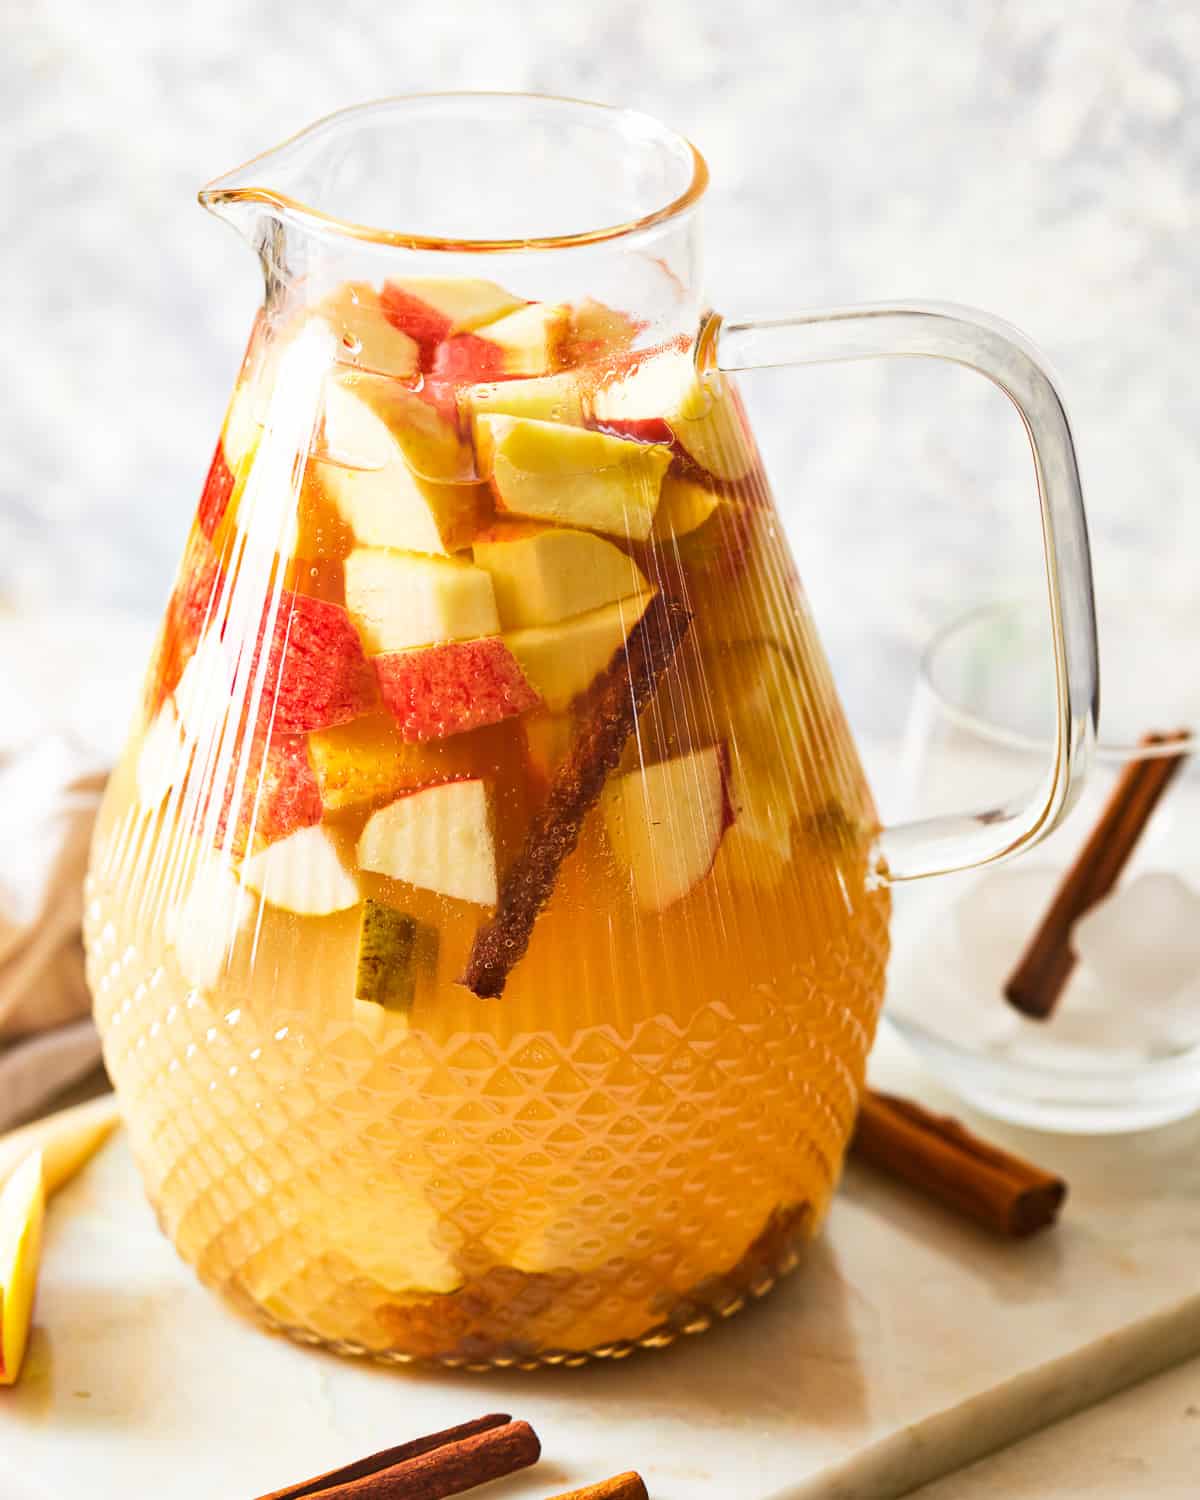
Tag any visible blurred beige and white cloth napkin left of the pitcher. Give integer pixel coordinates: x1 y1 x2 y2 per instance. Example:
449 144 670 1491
0 734 107 1130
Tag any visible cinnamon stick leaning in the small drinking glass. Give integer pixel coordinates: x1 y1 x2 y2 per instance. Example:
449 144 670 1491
1004 731 1191 1022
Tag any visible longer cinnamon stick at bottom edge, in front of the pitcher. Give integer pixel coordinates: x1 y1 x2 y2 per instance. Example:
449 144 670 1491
260 1413 542 1500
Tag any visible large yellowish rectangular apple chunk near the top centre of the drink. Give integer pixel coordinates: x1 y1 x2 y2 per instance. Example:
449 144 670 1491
476 416 671 542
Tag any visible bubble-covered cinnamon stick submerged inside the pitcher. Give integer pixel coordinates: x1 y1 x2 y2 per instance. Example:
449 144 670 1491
459 594 692 999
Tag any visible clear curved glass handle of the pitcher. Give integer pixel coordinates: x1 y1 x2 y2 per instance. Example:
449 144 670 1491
714 302 1100 881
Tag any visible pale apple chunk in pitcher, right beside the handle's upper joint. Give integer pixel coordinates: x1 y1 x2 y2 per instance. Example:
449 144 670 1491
591 348 755 480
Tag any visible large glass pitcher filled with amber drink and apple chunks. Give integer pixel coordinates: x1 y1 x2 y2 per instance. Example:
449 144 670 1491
87 95 1097 1368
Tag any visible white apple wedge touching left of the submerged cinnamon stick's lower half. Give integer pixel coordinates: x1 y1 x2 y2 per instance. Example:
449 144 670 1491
359 777 497 906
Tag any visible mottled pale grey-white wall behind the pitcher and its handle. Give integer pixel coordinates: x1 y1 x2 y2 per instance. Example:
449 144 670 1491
0 0 1200 728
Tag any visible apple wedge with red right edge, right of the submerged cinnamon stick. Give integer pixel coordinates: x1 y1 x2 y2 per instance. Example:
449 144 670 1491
603 746 734 912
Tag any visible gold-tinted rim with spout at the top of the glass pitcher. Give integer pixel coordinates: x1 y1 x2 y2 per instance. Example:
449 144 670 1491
198 89 708 255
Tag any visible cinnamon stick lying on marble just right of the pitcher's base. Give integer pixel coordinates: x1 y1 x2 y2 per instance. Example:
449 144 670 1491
851 1089 1067 1239
